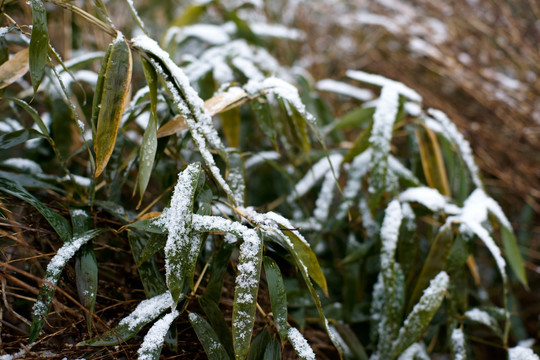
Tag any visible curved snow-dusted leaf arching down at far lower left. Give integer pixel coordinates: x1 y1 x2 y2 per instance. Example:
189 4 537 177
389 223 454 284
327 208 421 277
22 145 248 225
28 229 107 343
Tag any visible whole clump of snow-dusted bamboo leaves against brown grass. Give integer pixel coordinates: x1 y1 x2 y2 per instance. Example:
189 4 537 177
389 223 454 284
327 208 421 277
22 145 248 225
0 0 527 359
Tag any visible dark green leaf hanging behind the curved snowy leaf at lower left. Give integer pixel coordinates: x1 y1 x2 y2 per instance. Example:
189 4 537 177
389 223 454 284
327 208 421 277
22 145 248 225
69 207 98 334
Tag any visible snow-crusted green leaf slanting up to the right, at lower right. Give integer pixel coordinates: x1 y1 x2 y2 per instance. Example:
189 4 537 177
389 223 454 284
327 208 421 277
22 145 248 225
390 271 449 359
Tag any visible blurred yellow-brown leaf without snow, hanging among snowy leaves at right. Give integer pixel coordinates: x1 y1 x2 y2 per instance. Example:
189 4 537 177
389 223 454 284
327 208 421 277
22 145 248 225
415 123 450 196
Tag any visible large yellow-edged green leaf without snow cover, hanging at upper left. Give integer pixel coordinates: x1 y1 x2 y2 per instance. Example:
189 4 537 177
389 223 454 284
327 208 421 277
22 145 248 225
92 34 131 178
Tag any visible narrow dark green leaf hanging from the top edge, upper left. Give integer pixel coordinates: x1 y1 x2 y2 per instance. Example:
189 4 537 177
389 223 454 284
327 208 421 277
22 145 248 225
29 0 49 93
